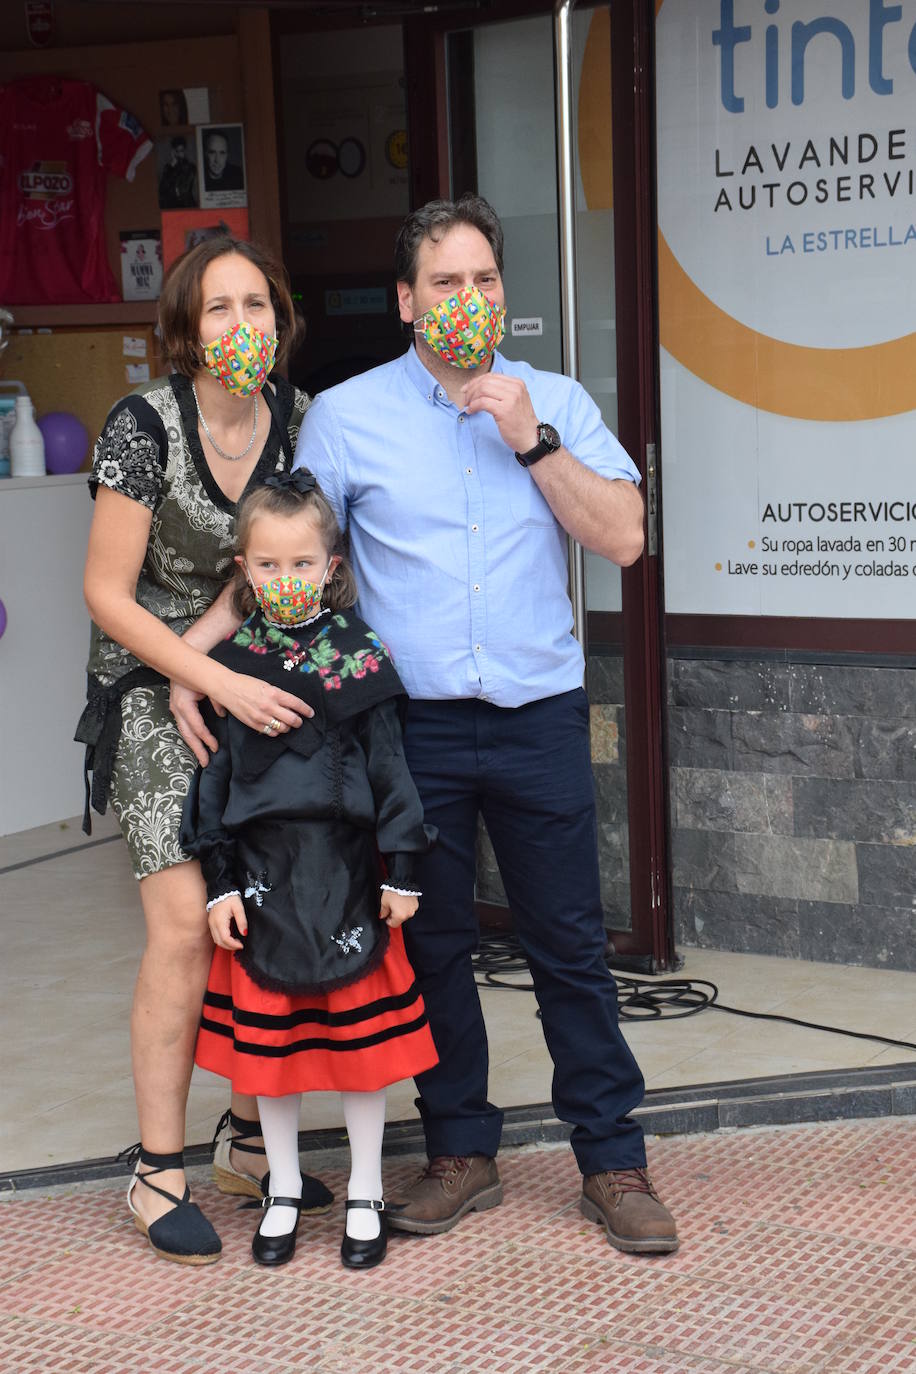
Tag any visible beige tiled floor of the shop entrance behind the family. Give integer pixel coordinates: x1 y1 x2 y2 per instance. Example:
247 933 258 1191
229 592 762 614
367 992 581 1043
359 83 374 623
0 818 916 1176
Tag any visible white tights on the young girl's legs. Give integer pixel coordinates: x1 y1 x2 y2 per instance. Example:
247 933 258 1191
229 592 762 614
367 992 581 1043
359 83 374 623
258 1088 385 1241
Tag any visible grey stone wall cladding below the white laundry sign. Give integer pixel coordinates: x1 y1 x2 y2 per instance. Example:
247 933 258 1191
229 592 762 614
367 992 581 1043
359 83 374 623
670 657 916 969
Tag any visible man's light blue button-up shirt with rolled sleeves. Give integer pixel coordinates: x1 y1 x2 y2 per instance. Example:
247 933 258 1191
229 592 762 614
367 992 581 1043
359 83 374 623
294 348 639 706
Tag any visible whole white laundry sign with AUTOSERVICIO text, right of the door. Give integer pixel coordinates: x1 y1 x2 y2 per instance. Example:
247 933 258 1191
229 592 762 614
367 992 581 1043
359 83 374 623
656 0 916 618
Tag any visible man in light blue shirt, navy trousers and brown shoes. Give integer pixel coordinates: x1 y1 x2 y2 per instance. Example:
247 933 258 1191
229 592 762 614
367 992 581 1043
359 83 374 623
295 195 677 1253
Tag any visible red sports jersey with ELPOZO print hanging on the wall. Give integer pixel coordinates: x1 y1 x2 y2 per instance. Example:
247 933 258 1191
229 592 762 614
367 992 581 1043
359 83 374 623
0 77 152 305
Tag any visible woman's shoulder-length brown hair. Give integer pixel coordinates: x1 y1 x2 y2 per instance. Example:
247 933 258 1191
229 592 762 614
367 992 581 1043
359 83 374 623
159 234 302 376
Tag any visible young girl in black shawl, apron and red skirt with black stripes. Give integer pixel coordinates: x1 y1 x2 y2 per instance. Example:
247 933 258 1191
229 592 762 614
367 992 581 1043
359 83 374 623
181 469 437 1268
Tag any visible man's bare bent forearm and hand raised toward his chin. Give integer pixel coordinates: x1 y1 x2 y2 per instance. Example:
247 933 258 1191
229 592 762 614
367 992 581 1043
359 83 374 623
464 372 643 567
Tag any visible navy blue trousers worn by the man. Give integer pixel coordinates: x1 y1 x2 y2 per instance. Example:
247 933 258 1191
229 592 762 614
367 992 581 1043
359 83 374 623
404 688 645 1173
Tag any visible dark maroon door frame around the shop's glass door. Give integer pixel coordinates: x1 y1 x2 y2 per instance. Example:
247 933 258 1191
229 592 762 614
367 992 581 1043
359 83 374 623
404 0 674 971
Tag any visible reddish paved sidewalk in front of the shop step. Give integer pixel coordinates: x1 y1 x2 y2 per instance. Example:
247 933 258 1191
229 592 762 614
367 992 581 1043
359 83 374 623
0 1117 916 1374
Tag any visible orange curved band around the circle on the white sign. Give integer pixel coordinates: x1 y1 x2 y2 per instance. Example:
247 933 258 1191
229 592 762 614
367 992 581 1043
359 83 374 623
655 0 916 420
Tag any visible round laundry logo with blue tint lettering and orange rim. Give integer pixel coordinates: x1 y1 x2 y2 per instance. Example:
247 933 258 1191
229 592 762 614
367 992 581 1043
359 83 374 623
656 0 916 420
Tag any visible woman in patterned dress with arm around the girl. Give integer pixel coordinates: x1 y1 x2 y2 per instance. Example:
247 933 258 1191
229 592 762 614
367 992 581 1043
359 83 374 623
77 236 331 1264
